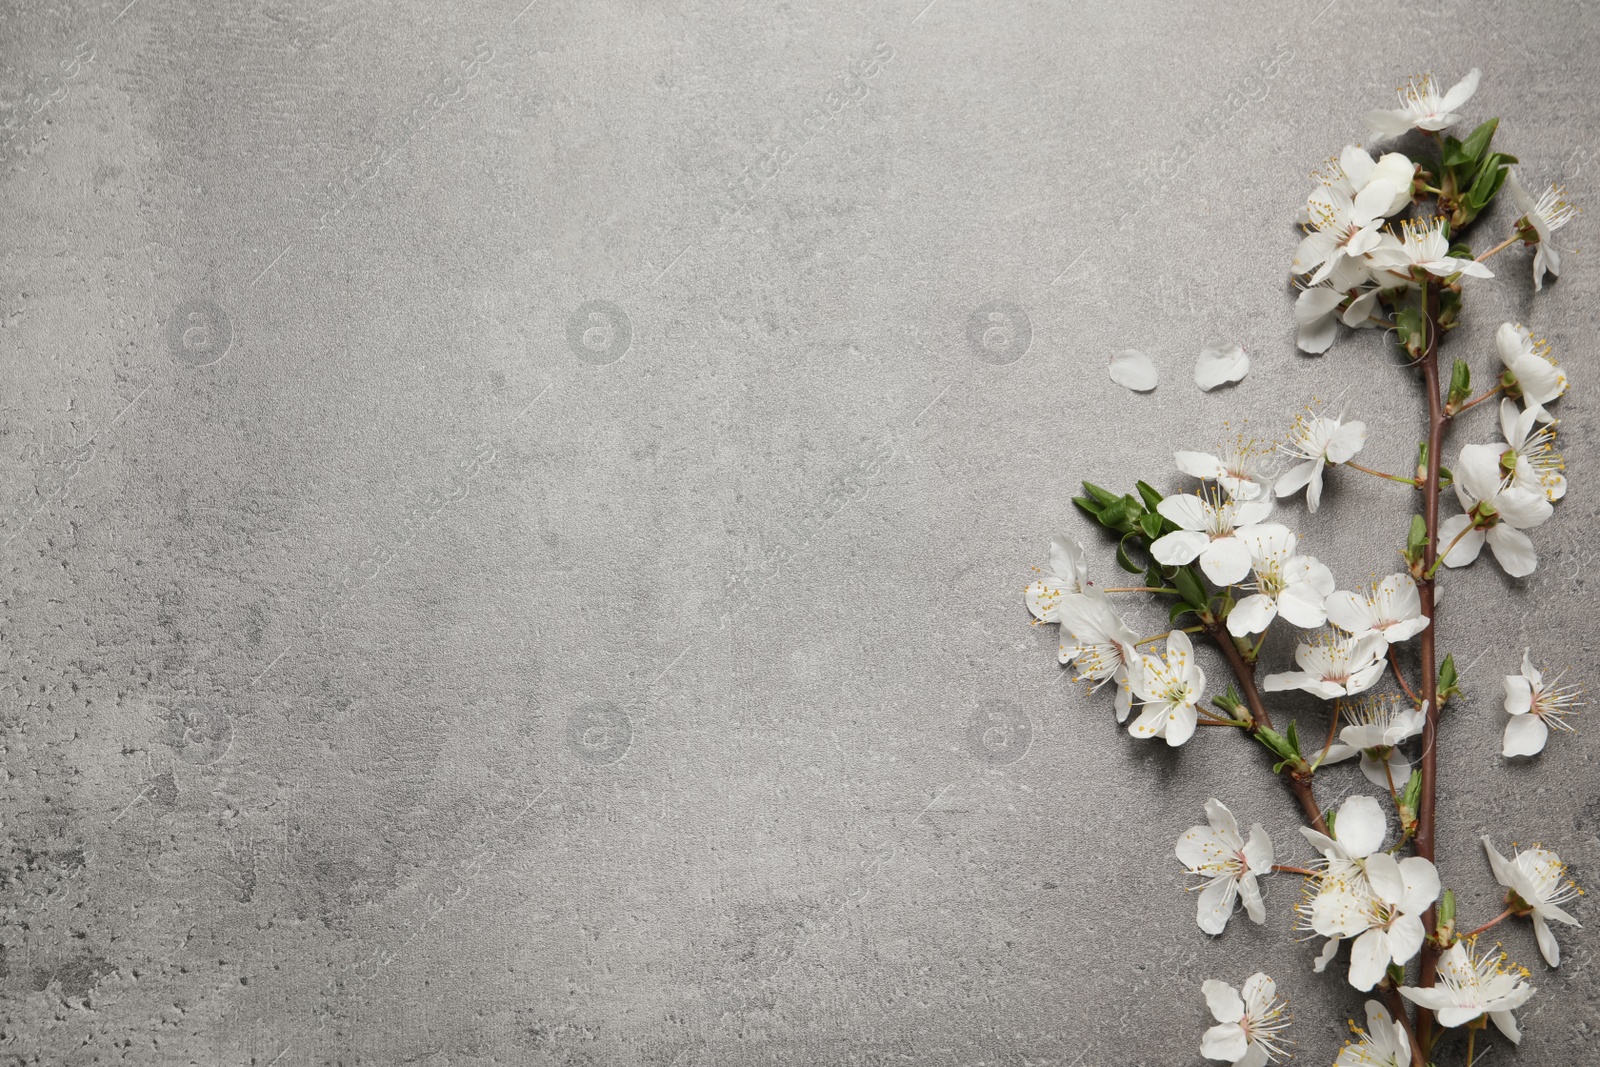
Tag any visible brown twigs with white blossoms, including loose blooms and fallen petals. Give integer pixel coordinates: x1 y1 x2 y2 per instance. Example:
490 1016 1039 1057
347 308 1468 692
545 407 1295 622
1026 70 1582 1067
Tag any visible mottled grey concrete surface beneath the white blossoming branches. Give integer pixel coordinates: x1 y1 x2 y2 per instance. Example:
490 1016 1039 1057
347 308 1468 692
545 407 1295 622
0 0 1600 1067
